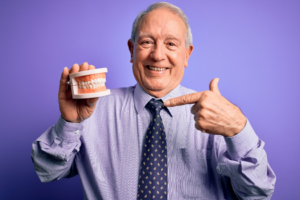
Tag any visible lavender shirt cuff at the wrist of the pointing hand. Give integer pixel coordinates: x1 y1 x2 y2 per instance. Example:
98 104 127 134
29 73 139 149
224 119 259 160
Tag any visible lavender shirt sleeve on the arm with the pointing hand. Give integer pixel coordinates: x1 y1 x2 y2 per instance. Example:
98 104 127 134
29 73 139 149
216 120 276 200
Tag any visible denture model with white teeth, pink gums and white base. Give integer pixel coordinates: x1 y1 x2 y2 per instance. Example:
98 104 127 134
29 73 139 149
69 68 110 99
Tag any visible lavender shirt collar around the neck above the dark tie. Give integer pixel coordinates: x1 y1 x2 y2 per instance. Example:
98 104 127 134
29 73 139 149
133 83 181 116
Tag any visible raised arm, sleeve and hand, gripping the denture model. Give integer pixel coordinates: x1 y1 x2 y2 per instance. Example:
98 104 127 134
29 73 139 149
31 63 98 182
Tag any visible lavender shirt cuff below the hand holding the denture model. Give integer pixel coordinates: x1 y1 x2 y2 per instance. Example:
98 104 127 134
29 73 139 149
55 116 83 142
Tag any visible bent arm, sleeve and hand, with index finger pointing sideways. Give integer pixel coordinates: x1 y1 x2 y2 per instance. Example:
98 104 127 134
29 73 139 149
165 78 276 199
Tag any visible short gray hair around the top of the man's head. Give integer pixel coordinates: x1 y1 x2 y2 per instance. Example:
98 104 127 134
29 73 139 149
131 2 193 48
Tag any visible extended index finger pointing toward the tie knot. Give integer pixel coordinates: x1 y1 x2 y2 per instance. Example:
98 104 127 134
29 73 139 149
164 92 203 107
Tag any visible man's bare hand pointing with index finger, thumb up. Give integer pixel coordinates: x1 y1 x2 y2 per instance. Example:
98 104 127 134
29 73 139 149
165 78 247 137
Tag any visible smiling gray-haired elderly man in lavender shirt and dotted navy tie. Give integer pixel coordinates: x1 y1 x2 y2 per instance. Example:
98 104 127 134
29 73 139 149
32 3 276 200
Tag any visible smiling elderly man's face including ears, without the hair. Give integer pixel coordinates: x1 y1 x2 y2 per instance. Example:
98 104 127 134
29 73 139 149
128 8 193 98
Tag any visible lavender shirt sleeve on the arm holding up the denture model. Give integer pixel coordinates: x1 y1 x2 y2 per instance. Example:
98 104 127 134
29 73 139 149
31 117 83 182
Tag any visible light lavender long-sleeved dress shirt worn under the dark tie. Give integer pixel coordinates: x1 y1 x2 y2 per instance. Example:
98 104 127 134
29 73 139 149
31 84 276 200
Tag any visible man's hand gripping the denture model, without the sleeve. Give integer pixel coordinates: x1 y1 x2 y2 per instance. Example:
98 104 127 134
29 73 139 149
58 62 98 123
